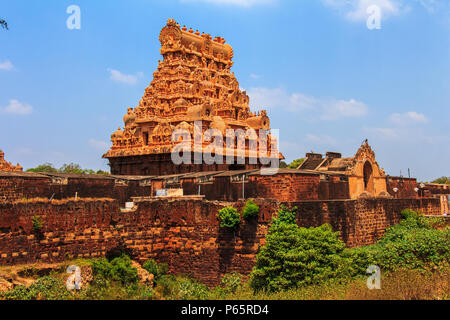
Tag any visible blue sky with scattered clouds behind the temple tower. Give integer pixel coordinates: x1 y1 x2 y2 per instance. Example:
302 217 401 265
0 0 450 180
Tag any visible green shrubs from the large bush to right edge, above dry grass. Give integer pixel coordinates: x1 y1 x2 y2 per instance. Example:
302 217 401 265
250 208 450 292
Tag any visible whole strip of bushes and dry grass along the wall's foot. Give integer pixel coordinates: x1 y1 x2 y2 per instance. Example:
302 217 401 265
0 207 450 300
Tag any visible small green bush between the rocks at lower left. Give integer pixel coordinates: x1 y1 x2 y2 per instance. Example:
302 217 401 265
92 254 139 285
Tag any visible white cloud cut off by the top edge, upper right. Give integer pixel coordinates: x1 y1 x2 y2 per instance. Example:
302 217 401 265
322 0 408 21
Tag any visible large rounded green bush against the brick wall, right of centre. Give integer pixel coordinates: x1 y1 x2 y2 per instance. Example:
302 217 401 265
250 207 352 292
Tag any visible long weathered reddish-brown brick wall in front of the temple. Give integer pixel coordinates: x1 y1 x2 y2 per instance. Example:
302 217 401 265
0 199 440 285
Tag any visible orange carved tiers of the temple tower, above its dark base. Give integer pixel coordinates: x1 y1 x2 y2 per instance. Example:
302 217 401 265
103 19 282 170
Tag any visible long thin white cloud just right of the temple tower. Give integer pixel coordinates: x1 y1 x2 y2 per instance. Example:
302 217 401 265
247 88 369 120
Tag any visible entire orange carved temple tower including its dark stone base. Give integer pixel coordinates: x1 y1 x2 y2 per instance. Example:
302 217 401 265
103 19 283 176
